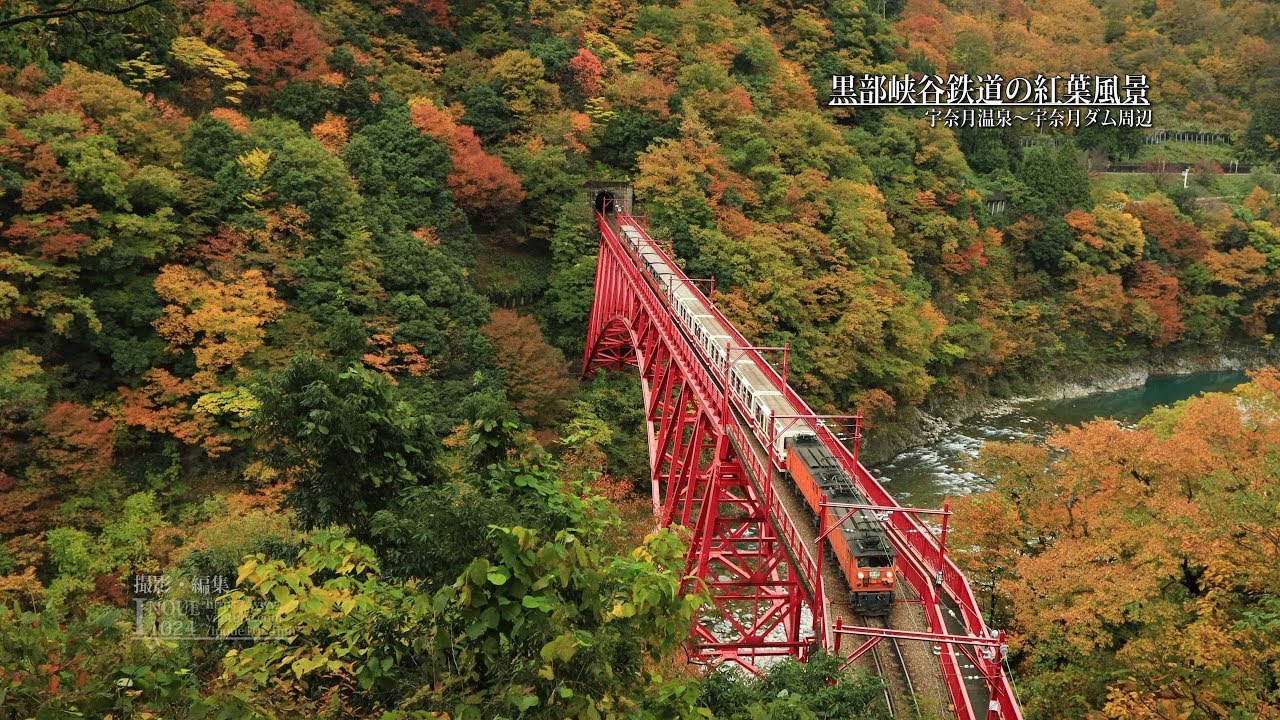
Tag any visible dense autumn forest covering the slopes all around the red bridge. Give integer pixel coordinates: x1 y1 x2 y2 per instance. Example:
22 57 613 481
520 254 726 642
0 0 1280 720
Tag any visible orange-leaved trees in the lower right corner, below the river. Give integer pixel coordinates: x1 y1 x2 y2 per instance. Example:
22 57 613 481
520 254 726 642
954 370 1280 720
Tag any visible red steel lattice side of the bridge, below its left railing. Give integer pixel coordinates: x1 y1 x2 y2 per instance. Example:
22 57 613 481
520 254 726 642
582 215 822 671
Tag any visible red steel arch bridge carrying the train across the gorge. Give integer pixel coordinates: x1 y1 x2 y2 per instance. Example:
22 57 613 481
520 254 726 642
582 193 1021 720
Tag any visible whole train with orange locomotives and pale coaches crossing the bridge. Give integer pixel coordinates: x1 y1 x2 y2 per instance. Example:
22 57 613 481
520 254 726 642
596 197 897 616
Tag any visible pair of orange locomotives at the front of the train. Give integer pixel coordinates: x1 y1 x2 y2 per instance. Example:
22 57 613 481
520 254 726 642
787 436 897 616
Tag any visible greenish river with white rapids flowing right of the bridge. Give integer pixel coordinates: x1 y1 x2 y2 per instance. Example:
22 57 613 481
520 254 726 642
868 372 1248 507
